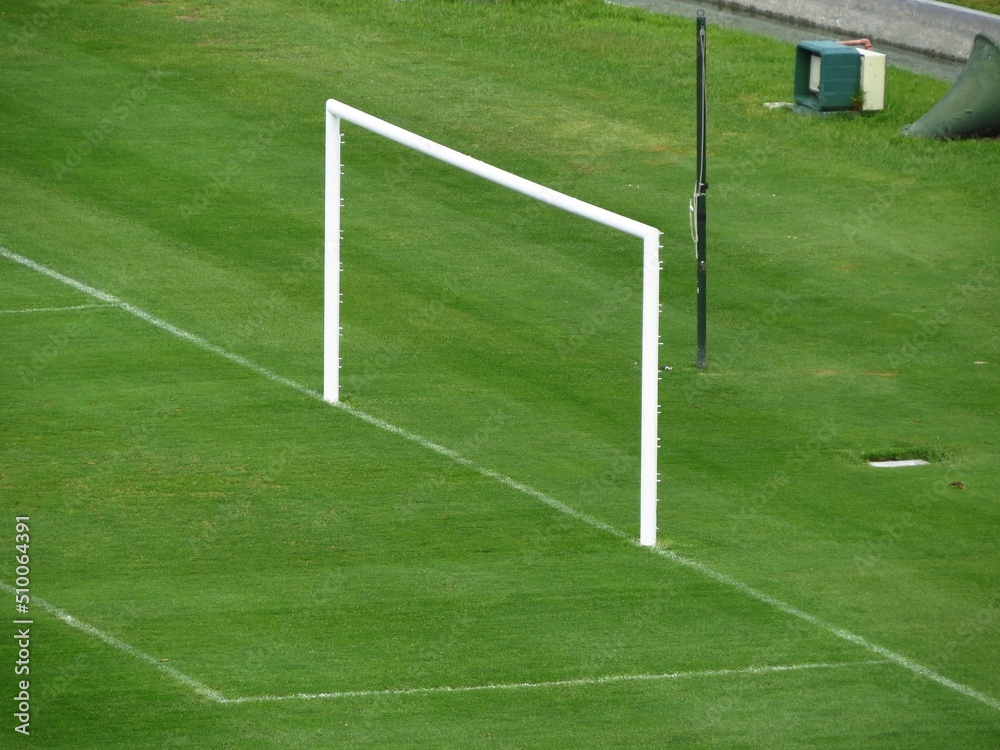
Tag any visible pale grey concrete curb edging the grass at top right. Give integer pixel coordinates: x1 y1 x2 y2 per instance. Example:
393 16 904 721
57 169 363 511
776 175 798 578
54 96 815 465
707 0 1000 60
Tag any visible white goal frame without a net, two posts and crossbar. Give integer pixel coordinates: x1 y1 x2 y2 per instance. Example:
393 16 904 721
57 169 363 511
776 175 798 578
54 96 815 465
323 99 661 547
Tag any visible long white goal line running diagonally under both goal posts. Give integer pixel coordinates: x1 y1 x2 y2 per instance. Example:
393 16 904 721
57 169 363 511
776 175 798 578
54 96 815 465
0 247 1000 711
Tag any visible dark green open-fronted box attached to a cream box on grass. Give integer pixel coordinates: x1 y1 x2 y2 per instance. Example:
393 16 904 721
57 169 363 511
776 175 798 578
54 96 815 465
795 42 861 112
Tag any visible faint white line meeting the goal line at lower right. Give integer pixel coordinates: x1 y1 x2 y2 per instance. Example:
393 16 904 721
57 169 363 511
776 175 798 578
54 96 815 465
222 660 889 703
